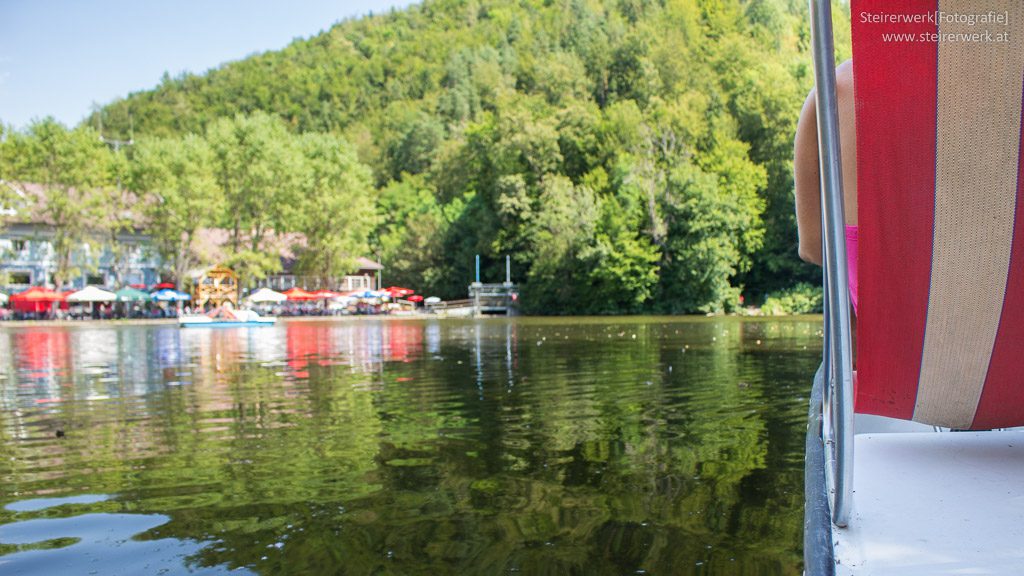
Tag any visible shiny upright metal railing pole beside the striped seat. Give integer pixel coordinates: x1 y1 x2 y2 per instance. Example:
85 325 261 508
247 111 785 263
810 0 854 527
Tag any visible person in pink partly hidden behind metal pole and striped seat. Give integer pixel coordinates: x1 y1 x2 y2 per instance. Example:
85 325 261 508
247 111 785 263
794 60 857 311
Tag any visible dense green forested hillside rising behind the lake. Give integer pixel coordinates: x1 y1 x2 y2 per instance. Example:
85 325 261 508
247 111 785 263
9 0 849 314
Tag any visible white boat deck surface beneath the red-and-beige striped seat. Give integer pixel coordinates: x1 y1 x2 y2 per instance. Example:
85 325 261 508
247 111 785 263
833 429 1024 576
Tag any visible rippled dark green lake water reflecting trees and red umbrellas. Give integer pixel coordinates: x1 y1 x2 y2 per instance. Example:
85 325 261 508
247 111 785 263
0 318 821 576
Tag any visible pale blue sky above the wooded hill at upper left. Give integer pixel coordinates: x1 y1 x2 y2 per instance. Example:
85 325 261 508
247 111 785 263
0 0 414 128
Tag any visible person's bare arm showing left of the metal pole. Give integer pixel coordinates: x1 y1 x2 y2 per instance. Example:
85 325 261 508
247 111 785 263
793 90 821 265
